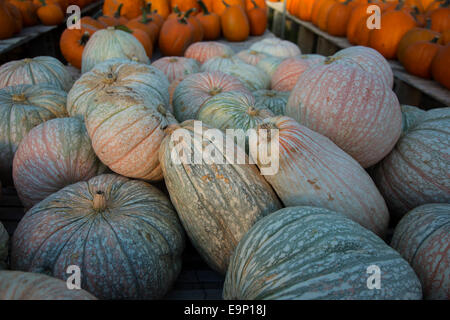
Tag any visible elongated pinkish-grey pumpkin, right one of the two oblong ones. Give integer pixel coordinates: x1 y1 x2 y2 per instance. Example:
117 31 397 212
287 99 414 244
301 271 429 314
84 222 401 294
253 117 389 237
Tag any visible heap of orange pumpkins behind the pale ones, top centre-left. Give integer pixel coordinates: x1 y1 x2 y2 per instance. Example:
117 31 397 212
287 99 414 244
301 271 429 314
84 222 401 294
60 0 267 68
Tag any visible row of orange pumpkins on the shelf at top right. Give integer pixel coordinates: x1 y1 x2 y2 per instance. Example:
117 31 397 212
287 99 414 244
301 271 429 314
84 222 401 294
287 0 450 88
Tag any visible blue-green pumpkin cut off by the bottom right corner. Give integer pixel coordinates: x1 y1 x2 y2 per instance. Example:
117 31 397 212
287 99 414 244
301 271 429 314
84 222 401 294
391 204 450 300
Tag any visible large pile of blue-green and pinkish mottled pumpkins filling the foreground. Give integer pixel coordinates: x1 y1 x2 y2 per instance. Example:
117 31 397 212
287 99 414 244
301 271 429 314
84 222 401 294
0 29 450 299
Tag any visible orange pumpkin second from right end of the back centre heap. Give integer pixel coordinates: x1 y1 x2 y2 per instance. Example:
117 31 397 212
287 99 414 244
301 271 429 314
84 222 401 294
221 1 250 41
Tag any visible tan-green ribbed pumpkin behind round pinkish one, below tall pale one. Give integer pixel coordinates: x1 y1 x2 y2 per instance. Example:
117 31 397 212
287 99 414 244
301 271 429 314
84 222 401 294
67 59 169 117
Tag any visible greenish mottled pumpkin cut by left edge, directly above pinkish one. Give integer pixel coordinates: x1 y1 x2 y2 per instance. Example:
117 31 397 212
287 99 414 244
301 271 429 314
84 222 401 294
0 84 67 183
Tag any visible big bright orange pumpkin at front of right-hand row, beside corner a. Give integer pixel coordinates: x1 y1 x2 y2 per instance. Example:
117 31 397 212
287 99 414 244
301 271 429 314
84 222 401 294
369 4 417 59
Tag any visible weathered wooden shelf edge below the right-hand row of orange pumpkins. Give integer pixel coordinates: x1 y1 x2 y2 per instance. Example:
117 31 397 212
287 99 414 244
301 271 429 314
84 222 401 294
267 1 450 109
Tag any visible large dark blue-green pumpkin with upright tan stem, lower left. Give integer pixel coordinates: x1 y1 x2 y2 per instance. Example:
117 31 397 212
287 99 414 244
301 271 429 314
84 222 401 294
11 174 184 299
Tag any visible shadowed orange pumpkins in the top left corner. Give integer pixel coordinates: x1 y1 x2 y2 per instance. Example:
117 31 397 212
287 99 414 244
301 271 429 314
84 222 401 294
0 0 94 40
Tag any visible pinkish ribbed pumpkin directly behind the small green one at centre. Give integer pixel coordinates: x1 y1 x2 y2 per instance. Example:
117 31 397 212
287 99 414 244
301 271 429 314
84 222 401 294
173 71 249 122
